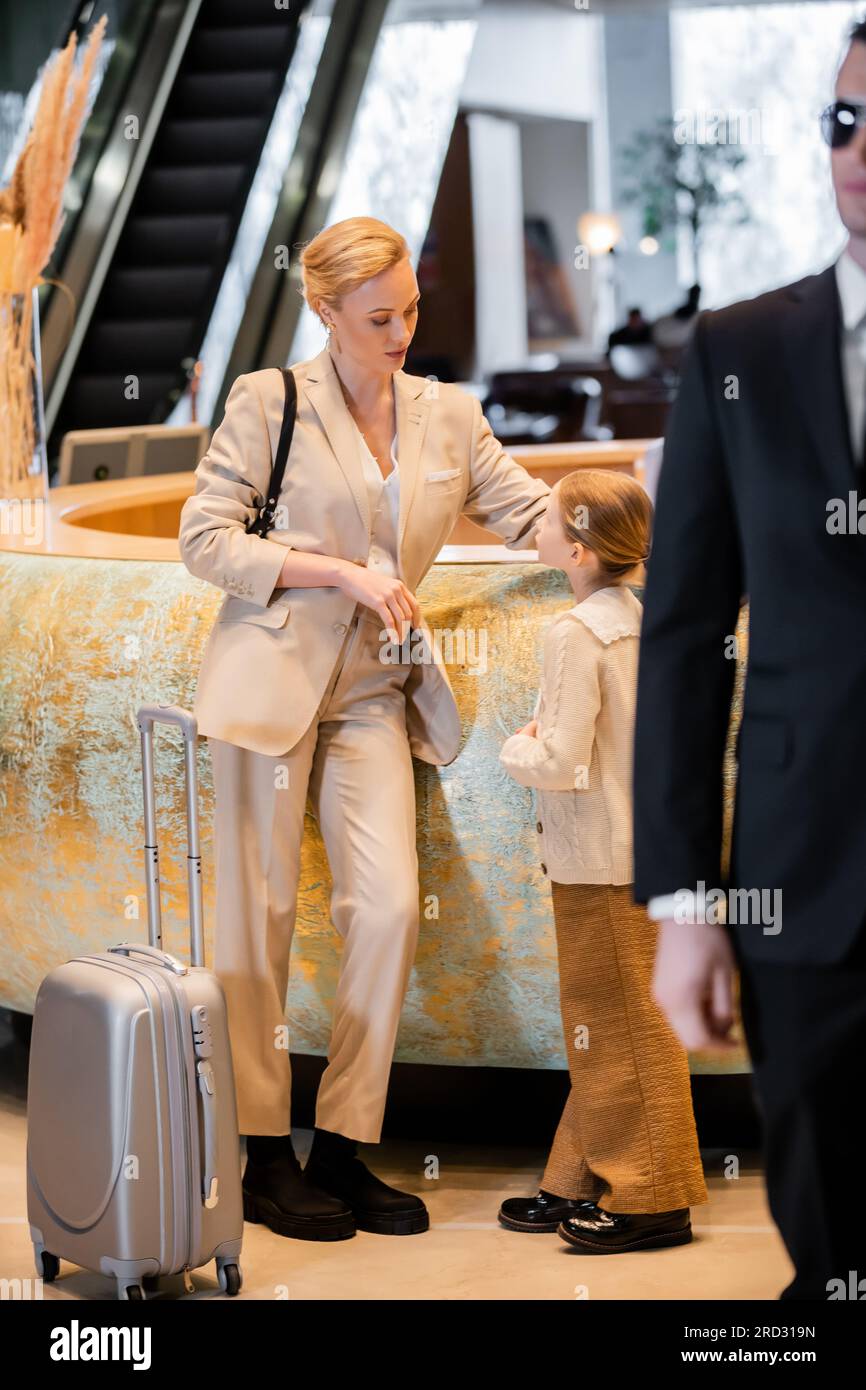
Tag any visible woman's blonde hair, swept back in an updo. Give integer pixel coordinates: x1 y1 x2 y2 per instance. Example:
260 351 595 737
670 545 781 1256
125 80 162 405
300 217 410 318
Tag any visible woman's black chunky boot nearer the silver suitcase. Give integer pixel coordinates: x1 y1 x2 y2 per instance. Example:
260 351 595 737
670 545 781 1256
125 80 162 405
242 1134 356 1240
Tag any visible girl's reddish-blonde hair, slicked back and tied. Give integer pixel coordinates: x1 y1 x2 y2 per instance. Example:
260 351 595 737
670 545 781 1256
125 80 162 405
556 468 653 580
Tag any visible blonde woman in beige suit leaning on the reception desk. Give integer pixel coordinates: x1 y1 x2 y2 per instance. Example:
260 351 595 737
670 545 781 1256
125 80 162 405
179 217 549 1240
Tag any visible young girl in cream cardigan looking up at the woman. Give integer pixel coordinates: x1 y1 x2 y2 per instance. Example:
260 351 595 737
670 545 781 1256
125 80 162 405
499 468 709 1254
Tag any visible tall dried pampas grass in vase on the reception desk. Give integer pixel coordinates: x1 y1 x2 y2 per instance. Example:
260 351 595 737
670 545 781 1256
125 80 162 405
0 15 108 498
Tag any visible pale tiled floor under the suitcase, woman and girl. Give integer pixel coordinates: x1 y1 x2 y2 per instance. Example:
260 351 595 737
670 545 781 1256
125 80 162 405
0 1033 791 1300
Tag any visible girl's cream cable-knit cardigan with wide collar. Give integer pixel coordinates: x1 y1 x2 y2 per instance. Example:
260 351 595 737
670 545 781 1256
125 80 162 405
499 584 644 884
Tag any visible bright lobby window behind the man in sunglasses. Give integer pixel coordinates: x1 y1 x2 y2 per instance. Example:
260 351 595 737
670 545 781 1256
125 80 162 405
670 0 863 309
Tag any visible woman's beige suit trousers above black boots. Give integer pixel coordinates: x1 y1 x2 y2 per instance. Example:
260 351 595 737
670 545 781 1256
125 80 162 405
209 603 420 1143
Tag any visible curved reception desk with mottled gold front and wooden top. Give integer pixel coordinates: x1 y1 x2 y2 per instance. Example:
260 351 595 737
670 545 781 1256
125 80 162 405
0 441 748 1072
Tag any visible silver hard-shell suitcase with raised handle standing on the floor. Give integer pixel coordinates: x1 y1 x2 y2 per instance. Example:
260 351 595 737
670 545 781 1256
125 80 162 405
26 705 243 1298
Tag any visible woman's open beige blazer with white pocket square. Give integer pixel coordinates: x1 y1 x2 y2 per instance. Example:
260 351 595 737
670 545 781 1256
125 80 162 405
179 348 550 765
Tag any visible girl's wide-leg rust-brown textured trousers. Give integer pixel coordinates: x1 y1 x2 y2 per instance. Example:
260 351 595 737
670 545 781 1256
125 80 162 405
541 883 709 1213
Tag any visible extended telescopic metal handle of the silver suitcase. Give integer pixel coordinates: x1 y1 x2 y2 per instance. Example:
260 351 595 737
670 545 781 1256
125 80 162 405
136 705 204 965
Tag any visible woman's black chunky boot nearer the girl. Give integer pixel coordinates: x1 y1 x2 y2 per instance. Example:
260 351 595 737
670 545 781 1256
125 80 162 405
303 1129 430 1236
